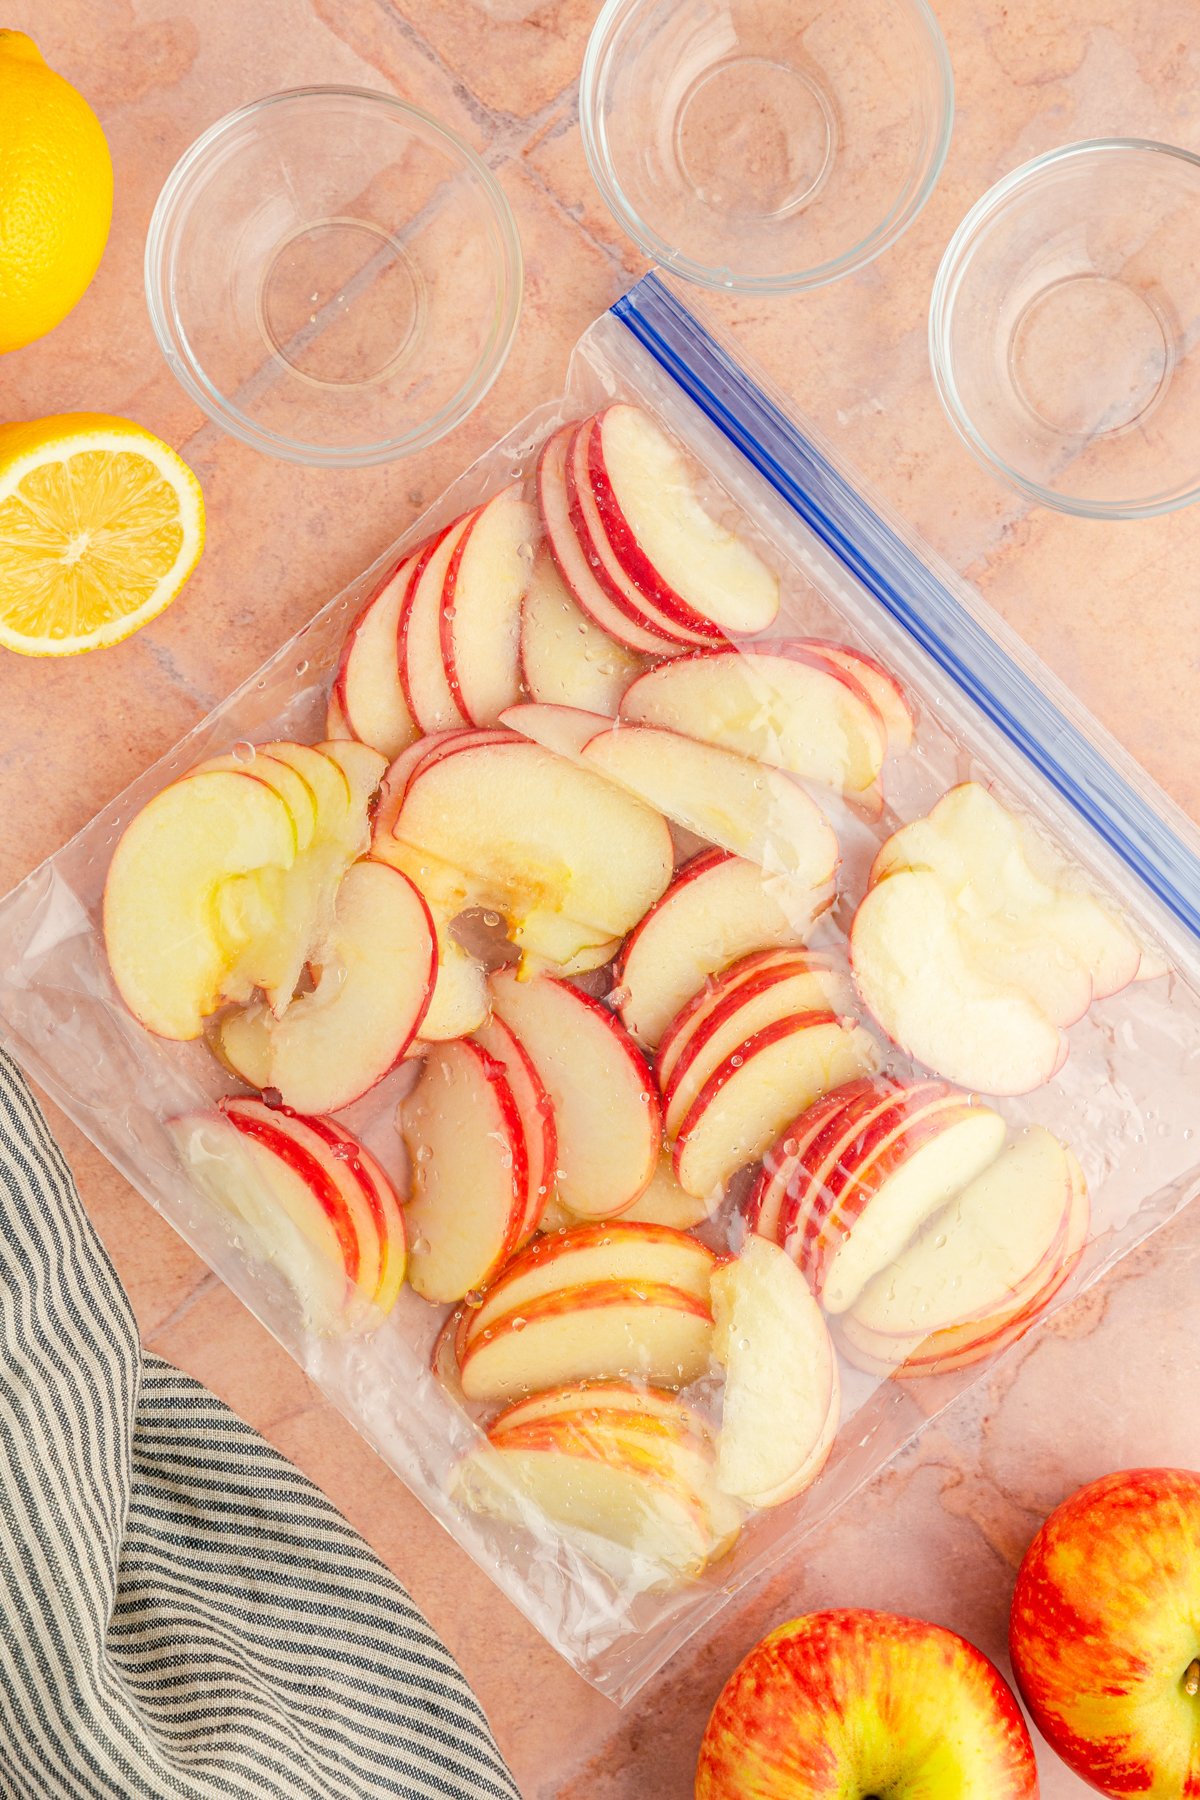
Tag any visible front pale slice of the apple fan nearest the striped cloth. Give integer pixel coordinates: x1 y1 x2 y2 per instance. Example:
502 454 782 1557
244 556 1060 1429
167 1112 358 1330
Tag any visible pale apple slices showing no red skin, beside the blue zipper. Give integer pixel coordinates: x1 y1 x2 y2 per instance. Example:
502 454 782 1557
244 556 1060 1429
851 781 1157 1094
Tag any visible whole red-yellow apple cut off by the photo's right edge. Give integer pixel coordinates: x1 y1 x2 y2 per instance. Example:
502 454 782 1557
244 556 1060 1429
1009 1469 1200 1800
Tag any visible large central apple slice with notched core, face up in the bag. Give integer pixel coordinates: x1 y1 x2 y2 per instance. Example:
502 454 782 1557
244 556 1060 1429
394 742 673 961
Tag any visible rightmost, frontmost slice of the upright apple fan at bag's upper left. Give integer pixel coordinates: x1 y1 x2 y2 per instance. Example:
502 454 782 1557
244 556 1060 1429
439 486 538 725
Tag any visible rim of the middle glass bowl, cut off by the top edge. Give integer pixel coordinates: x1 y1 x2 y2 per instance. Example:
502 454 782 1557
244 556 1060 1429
579 0 955 293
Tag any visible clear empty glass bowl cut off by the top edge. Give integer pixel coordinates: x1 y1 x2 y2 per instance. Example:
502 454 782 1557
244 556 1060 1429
579 0 954 293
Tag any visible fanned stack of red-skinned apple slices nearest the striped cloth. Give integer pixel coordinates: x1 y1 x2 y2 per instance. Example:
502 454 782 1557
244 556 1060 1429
169 1096 407 1332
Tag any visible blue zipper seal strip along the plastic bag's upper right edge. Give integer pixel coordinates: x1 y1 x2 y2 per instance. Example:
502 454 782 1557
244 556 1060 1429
612 274 1200 940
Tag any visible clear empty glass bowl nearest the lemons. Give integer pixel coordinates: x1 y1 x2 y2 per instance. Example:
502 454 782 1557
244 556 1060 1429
146 88 522 468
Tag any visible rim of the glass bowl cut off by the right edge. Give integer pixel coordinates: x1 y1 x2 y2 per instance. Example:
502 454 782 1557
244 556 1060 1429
928 137 1200 518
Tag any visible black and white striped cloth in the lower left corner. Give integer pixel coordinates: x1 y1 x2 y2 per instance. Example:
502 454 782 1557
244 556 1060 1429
0 1057 520 1800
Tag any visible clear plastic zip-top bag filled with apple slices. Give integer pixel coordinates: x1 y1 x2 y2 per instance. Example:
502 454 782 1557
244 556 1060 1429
0 277 1200 1701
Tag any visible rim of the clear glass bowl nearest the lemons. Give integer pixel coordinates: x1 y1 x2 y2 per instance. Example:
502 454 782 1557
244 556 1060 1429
142 83 524 468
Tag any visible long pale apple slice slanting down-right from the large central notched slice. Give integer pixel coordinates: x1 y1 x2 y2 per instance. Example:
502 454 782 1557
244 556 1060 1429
583 725 838 896
